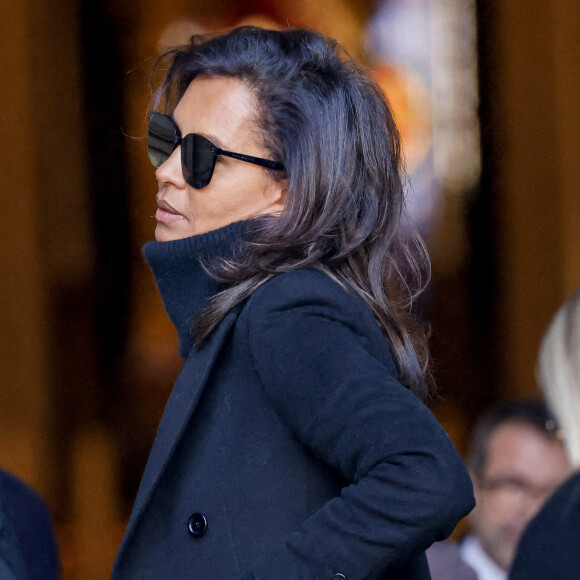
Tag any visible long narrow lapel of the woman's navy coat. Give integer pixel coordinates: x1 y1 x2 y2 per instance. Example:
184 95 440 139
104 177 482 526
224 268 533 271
117 310 238 561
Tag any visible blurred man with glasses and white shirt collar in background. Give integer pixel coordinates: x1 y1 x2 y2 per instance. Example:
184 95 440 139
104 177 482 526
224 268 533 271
428 399 570 580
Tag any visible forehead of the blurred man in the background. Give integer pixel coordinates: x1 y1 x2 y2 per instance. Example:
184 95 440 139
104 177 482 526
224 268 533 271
484 423 568 482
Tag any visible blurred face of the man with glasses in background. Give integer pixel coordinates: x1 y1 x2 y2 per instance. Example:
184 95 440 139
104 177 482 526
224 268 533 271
470 423 570 571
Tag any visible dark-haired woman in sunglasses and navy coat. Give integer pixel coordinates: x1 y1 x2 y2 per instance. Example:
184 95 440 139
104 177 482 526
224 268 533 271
113 27 473 580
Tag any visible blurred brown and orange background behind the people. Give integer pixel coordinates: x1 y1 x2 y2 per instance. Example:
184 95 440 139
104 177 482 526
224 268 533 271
0 0 580 579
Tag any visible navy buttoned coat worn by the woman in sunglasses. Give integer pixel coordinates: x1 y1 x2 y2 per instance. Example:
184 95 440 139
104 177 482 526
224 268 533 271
113 270 474 580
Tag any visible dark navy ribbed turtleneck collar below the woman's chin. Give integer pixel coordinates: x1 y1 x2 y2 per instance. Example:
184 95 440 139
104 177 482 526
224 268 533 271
143 222 247 357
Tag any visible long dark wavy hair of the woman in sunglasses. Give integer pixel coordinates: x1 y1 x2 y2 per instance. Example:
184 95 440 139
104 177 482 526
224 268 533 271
156 26 431 398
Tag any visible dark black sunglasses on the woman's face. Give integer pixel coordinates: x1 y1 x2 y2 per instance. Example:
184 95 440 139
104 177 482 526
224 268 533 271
147 111 284 189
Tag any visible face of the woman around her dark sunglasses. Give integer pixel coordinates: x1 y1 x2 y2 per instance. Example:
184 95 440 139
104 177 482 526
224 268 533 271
155 77 284 242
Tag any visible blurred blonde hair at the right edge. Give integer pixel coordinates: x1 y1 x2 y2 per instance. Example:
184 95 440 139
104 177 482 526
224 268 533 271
538 289 580 468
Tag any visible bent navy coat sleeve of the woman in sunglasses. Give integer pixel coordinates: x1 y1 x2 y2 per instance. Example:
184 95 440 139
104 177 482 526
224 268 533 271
242 272 474 580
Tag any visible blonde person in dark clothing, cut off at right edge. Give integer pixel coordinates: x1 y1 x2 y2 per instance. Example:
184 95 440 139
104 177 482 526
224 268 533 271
510 290 580 580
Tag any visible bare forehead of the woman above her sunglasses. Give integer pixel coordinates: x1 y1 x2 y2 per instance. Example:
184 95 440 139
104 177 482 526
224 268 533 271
173 76 256 147
